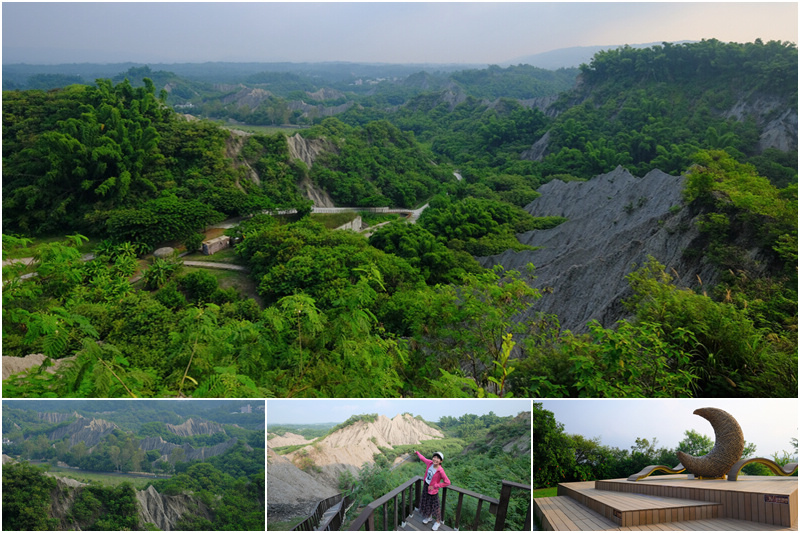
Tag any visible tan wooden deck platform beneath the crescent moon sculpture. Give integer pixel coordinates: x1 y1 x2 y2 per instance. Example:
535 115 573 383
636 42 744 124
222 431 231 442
534 474 797 531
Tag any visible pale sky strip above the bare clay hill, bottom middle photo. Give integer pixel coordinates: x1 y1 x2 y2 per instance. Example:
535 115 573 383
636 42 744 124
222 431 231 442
267 399 531 425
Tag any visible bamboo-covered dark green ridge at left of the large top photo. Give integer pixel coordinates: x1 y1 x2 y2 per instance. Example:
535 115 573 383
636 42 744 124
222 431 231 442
3 79 298 239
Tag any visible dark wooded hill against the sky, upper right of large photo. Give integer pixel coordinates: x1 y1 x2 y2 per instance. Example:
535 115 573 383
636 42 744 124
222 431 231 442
542 39 797 182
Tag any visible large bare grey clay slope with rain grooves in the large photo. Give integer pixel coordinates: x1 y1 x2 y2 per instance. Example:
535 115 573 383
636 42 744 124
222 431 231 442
478 167 717 332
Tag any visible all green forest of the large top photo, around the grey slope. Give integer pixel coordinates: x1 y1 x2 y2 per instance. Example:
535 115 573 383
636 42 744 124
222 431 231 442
3 40 797 397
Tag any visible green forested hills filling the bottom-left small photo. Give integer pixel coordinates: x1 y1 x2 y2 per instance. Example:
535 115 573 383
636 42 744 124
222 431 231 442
3 401 265 531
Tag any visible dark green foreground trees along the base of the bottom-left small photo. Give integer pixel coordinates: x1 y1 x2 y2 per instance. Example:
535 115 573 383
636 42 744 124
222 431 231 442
3 455 265 531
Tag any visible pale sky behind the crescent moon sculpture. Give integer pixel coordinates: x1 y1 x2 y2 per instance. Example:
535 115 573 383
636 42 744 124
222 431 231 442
536 399 798 457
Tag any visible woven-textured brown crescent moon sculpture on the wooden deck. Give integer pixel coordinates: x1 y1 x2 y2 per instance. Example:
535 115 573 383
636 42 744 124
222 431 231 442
678 407 744 478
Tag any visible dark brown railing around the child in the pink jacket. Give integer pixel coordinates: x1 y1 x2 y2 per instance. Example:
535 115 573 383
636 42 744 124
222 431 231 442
350 476 531 531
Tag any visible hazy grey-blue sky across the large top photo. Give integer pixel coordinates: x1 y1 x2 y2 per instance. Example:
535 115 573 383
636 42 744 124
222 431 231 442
2 1 798 64
